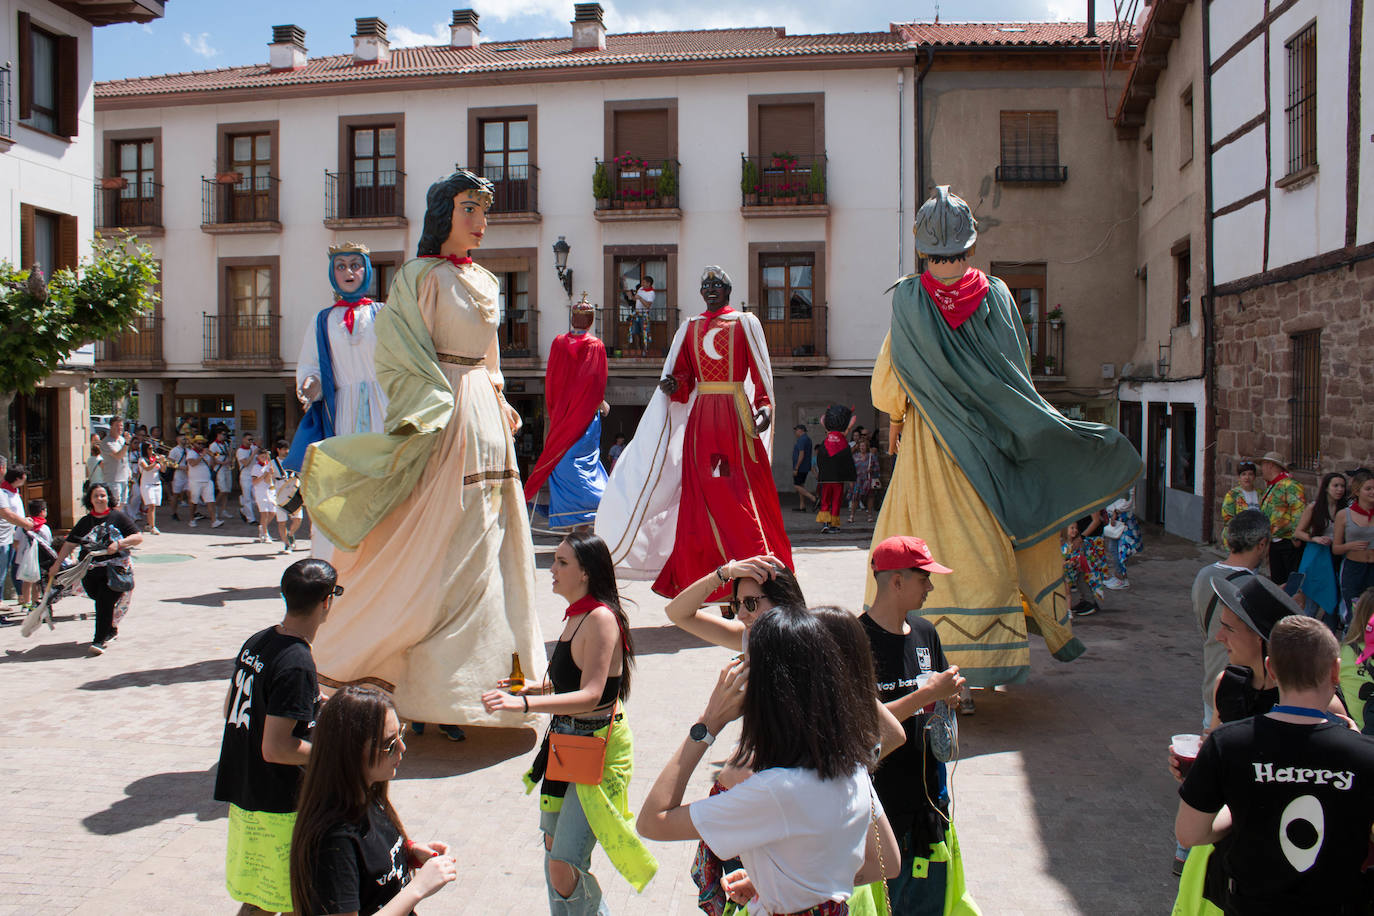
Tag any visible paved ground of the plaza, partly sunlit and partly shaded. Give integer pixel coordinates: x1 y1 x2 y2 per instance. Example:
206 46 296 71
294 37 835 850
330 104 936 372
0 513 1212 916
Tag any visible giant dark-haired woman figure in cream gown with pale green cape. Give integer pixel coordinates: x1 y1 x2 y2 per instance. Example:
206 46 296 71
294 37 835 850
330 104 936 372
301 170 544 725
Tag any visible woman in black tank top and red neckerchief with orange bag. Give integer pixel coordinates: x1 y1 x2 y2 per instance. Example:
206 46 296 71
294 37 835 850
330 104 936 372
482 533 658 916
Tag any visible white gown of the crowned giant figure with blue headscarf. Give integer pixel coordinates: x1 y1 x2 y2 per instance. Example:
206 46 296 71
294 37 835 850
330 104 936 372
295 302 386 435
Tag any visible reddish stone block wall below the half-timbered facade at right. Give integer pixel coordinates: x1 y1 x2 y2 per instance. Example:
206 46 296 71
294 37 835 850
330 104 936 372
1212 260 1374 531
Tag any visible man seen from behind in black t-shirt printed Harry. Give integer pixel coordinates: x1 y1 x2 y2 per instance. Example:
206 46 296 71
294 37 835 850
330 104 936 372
1175 617 1374 916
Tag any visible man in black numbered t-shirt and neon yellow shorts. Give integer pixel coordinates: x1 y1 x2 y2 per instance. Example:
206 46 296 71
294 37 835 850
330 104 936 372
214 559 344 916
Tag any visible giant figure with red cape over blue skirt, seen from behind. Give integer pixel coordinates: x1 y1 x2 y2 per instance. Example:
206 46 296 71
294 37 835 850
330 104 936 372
525 293 609 530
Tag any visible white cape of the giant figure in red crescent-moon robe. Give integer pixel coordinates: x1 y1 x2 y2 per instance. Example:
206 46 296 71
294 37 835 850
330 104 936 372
596 312 776 580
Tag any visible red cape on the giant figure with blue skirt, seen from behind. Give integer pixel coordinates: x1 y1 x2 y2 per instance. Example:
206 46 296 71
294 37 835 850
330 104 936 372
525 331 606 503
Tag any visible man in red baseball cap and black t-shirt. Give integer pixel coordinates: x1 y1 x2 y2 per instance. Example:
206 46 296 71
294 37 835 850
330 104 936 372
859 537 963 916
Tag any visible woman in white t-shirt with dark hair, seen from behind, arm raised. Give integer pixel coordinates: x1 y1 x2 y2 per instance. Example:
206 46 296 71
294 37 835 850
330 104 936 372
639 606 897 916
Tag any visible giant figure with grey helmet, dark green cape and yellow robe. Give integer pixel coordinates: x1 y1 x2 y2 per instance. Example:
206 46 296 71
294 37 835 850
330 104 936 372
866 185 1142 687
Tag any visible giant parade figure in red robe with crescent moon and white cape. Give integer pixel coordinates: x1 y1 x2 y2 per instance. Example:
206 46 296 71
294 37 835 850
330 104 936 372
596 266 791 600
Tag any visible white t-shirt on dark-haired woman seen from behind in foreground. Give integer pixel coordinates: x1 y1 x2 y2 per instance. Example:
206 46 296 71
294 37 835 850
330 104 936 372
687 768 879 913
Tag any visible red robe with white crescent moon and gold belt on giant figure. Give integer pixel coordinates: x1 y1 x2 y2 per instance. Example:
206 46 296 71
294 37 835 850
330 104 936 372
654 305 791 599
